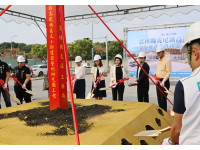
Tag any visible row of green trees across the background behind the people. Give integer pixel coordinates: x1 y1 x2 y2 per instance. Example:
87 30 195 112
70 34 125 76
0 39 123 60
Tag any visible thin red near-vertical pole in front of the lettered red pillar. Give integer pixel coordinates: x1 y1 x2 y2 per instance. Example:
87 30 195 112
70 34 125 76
59 5 80 145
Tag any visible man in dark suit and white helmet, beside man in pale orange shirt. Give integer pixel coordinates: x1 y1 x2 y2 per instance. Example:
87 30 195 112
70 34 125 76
136 52 150 102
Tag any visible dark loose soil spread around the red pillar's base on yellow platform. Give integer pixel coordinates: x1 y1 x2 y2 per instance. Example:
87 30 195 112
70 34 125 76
0 102 124 135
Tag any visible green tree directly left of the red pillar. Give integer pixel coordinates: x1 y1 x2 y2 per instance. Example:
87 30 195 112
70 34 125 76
31 44 47 60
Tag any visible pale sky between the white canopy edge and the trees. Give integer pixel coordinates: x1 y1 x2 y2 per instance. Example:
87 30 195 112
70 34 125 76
0 6 200 44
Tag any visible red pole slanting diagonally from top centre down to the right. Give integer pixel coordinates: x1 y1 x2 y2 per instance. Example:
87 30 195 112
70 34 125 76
88 5 173 105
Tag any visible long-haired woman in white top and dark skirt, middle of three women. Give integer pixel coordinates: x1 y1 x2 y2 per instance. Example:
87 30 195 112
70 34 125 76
91 55 107 100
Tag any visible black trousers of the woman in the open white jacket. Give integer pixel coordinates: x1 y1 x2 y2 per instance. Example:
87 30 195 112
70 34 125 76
112 84 125 101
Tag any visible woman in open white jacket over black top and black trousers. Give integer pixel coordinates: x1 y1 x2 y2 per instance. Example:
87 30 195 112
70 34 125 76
110 54 129 101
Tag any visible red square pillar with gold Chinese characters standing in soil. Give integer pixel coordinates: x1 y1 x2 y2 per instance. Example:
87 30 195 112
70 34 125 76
46 5 68 110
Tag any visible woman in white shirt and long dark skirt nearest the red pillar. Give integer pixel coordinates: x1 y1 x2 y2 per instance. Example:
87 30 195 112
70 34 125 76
73 56 85 99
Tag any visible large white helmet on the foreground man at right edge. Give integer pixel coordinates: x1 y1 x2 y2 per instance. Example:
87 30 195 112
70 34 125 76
181 21 200 51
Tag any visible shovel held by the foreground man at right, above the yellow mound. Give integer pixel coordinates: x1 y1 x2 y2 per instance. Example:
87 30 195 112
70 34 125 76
133 126 171 137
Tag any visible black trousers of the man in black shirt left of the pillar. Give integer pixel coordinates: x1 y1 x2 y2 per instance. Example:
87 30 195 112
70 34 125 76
14 85 32 104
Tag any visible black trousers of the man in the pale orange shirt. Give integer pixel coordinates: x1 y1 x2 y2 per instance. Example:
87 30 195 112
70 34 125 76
156 79 170 111
